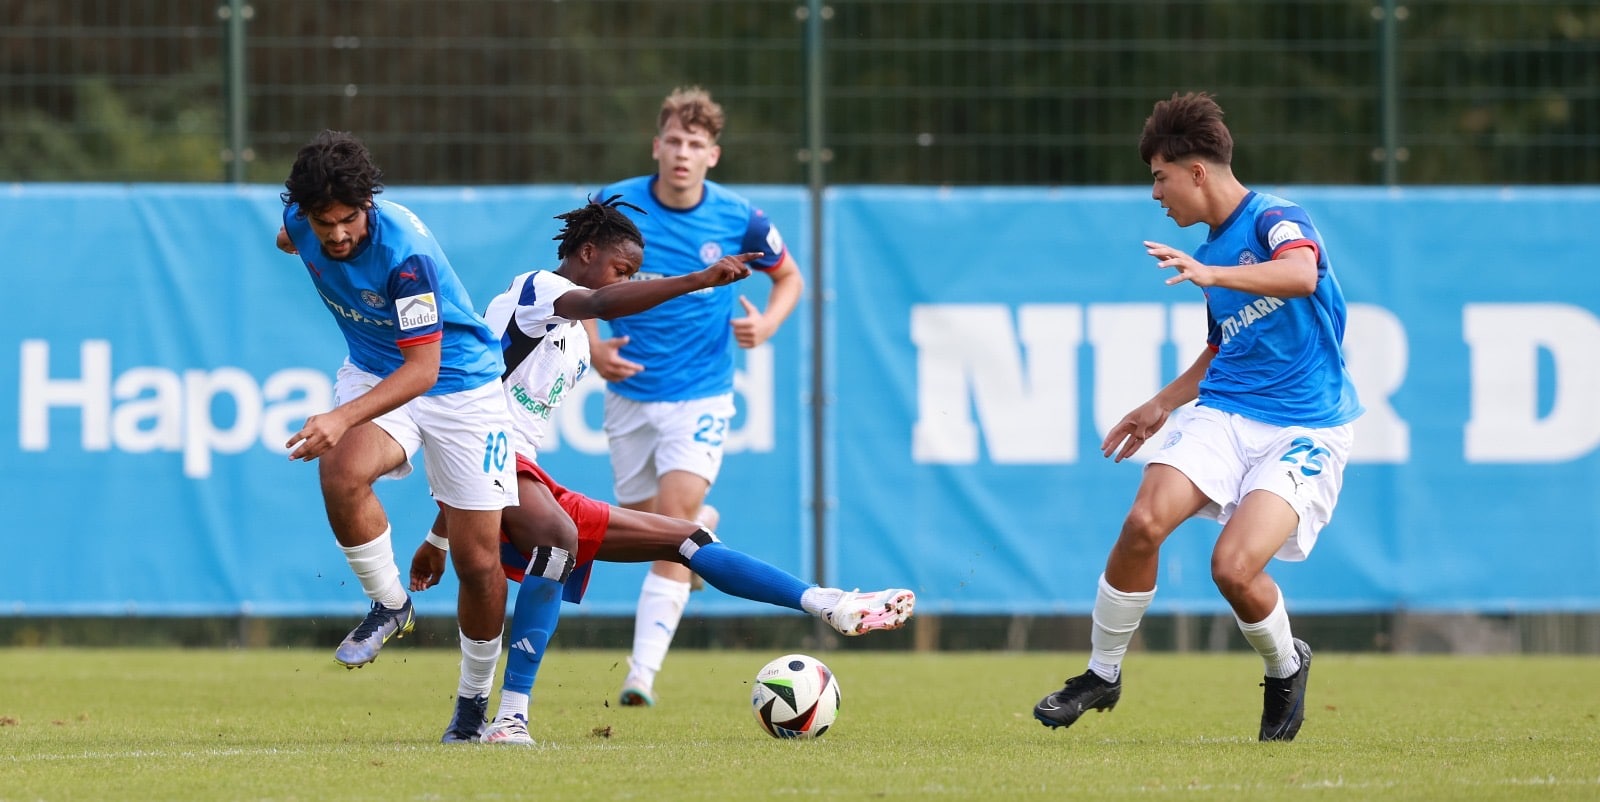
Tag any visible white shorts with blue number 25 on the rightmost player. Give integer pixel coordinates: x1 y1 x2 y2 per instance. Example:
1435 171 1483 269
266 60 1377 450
1150 405 1354 562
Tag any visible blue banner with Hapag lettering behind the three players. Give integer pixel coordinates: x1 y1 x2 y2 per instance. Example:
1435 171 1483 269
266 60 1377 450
0 184 800 615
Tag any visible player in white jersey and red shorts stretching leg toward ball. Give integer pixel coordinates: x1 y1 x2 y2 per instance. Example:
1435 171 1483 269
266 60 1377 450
411 197 915 744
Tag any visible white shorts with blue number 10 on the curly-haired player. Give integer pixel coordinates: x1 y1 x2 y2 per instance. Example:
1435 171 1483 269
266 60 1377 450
333 360 517 509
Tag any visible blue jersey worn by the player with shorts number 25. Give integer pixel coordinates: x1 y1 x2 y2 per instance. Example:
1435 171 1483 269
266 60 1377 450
1194 192 1363 429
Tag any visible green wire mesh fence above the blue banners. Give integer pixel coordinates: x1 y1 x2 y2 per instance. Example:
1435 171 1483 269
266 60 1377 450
0 0 1600 186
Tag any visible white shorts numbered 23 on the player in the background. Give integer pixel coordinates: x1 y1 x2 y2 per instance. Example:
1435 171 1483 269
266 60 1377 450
605 391 734 504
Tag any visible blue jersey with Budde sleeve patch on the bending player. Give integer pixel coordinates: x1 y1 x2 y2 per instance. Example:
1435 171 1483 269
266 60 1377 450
283 200 504 395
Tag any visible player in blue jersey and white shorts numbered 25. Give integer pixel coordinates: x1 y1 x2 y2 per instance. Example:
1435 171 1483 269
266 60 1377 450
1034 93 1362 741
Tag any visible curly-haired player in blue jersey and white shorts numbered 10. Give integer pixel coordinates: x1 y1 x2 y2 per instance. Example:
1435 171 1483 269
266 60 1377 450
277 131 517 736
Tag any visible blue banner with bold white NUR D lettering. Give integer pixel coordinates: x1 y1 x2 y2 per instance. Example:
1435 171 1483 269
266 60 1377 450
824 187 1600 613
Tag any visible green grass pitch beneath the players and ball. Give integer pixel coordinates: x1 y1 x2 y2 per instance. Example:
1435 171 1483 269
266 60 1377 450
0 640 1600 802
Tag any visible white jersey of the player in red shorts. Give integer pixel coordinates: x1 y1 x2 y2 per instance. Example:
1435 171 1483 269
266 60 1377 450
483 271 589 459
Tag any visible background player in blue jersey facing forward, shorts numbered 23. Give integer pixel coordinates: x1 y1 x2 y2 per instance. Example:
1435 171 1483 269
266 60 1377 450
587 86 805 706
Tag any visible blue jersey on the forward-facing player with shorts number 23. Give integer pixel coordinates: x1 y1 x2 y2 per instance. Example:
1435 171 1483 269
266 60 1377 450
597 174 786 402
